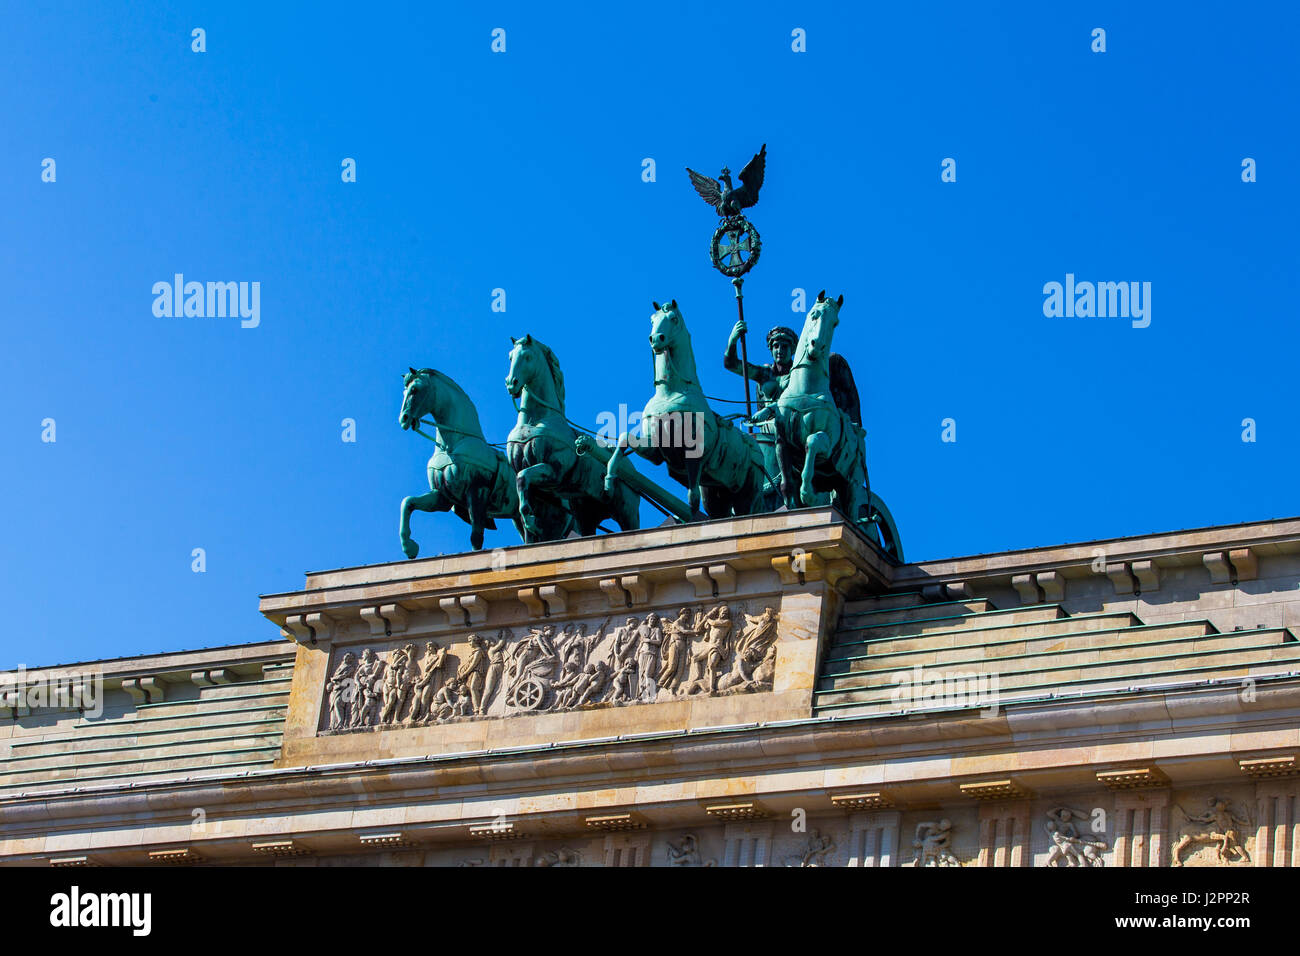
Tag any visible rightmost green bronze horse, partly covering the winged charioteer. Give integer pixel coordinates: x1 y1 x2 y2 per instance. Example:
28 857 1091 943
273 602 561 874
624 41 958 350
754 290 902 561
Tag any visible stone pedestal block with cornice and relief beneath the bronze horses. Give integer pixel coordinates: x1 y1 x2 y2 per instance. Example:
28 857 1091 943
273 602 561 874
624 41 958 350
261 509 887 767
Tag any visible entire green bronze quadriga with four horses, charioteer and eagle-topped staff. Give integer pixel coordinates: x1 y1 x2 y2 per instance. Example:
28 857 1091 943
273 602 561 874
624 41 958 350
387 139 902 562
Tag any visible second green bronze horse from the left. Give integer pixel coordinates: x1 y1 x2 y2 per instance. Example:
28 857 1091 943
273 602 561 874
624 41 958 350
506 336 641 542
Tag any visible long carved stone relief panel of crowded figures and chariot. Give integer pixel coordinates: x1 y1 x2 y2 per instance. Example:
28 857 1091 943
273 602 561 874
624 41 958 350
322 604 780 734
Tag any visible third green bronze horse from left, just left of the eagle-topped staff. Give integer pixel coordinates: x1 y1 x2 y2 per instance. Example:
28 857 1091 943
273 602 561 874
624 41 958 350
606 299 766 518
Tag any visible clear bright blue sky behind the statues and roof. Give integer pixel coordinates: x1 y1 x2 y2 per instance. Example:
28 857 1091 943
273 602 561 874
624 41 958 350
0 3 1300 666
